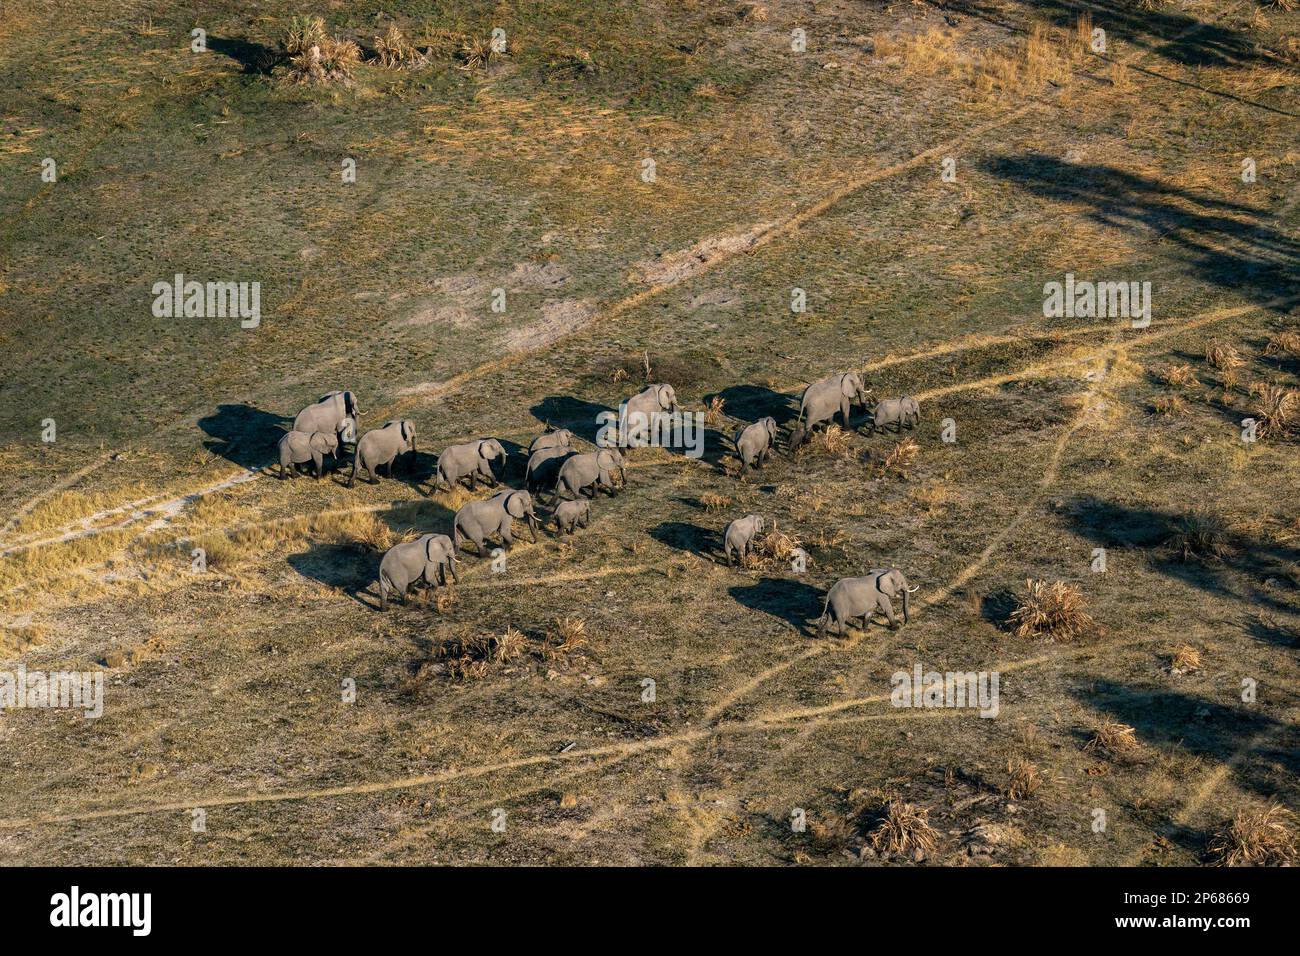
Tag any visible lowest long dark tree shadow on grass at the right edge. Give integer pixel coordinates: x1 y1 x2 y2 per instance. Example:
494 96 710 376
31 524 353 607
1071 680 1300 851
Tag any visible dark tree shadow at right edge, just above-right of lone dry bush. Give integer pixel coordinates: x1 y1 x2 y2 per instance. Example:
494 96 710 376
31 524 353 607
1062 497 1300 634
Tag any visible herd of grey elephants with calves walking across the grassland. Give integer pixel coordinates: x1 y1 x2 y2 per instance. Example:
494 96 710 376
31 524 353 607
280 372 920 636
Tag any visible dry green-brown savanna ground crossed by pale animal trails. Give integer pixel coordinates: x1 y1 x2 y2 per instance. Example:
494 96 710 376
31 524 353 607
0 0 1300 865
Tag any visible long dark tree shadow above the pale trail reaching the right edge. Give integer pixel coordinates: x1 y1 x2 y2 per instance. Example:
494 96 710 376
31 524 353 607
985 153 1300 312
